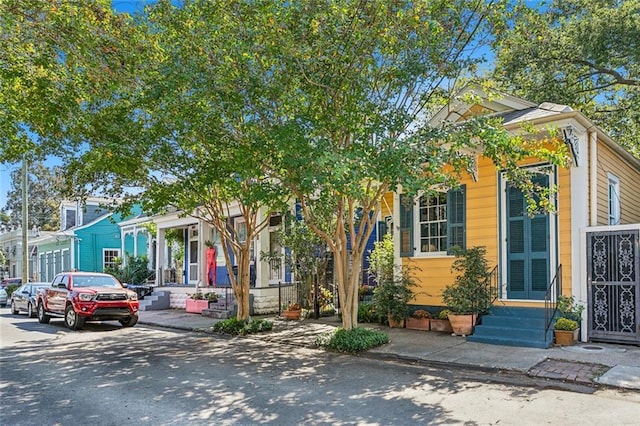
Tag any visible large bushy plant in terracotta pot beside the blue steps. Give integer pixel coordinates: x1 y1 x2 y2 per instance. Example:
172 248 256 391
442 246 493 336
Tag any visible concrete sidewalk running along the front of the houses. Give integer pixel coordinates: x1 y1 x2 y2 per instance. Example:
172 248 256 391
138 309 640 390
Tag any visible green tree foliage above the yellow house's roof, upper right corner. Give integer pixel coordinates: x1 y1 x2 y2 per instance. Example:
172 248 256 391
494 0 640 157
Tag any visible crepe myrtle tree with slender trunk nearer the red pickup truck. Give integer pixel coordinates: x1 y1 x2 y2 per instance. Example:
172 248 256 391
56 2 290 319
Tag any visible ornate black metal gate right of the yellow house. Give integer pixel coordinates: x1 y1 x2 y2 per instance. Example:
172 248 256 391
587 229 640 343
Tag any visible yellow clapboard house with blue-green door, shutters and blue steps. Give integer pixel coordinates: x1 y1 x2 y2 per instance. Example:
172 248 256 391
390 88 640 347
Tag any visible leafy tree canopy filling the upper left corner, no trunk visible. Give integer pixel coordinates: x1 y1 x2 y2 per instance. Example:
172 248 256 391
0 0 149 164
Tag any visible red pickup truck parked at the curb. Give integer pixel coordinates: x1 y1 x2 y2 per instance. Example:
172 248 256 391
36 272 139 330
